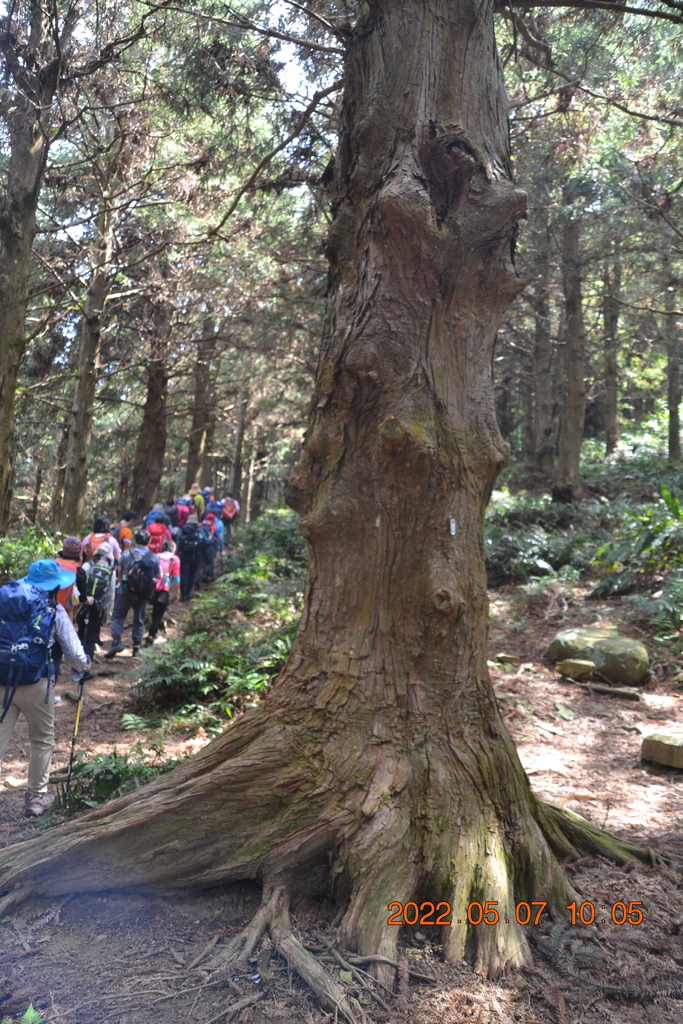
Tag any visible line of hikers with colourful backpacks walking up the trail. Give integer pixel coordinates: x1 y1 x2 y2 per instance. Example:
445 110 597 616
0 484 240 817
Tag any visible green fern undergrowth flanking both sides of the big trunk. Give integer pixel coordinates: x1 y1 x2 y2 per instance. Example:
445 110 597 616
120 425 683 735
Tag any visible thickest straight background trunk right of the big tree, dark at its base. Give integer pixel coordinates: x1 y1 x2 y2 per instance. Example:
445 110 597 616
553 215 586 502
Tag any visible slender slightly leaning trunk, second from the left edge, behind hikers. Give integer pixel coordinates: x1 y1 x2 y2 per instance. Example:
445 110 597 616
61 200 116 536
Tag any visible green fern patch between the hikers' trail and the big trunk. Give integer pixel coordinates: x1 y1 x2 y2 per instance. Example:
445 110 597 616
132 510 306 720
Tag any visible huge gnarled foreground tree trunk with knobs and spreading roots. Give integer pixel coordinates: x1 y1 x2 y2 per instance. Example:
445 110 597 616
0 0 647 1017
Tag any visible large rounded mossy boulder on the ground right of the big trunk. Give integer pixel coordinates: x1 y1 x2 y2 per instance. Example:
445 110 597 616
548 626 650 686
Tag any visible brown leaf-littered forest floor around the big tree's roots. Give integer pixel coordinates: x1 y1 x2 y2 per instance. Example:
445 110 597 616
0 586 683 1024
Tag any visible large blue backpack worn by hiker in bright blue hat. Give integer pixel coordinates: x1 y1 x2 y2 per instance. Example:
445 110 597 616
0 580 56 722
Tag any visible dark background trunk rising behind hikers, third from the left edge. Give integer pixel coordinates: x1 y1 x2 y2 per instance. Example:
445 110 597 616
130 301 171 515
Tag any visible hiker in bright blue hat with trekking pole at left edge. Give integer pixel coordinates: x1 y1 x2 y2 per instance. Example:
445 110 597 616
0 558 90 818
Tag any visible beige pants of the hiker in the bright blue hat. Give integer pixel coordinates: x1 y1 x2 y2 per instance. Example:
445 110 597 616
0 679 54 793
